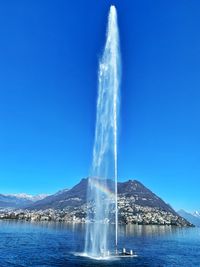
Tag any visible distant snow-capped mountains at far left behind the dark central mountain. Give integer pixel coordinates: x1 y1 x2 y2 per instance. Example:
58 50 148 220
0 193 47 208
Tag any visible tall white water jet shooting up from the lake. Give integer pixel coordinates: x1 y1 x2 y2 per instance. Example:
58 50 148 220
85 6 120 257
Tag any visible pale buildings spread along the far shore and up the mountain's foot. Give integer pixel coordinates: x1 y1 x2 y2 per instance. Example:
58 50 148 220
0 196 190 226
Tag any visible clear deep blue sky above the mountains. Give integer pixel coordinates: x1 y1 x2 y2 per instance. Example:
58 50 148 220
0 0 200 214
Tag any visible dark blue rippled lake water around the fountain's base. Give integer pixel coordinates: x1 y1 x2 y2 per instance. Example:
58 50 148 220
0 221 200 267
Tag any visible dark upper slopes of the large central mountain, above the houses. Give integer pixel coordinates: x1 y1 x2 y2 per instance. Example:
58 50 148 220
28 178 173 214
